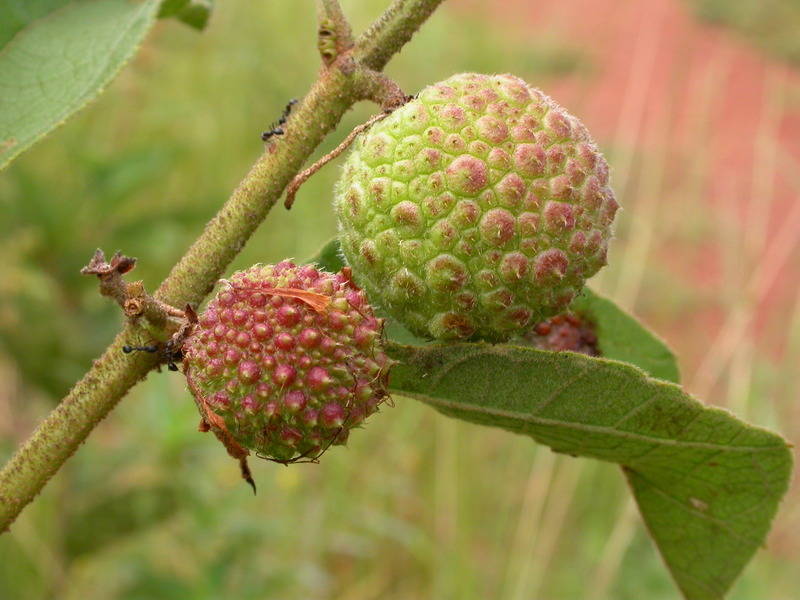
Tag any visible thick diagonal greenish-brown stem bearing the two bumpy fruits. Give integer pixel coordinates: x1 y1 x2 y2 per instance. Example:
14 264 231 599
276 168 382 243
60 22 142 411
0 0 443 532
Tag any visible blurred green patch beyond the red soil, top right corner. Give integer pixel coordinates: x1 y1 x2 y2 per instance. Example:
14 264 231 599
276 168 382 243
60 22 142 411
689 0 800 64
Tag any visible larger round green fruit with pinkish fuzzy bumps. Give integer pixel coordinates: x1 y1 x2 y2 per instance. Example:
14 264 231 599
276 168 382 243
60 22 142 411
335 73 618 341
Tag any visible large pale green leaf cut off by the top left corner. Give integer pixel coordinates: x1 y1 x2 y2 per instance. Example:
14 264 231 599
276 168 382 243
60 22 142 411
0 0 159 169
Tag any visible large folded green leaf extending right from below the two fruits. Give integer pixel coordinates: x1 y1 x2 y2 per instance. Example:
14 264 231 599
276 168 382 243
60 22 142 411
388 343 792 600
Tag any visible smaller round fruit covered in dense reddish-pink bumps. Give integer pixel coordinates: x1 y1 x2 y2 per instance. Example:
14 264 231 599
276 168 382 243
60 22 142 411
183 262 391 461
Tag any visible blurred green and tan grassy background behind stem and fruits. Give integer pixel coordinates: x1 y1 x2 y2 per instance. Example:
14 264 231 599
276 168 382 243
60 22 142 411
0 0 800 600
